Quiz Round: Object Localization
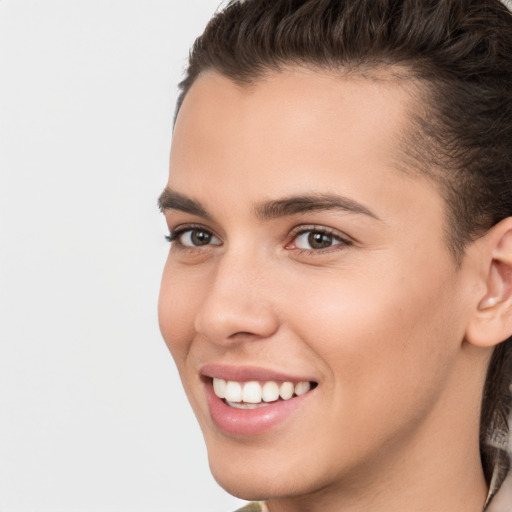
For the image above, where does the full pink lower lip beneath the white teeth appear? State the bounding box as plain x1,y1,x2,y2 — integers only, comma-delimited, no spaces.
206,383,311,436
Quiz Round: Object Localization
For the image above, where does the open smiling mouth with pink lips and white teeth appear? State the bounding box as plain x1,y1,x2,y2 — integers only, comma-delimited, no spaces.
201,365,316,436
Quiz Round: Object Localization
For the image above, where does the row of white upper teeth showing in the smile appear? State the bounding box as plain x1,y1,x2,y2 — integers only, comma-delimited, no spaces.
213,378,311,404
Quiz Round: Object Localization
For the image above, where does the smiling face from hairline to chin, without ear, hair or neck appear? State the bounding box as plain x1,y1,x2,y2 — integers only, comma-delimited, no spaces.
159,69,476,499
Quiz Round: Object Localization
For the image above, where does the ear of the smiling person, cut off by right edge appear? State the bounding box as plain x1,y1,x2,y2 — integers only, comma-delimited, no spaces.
466,217,512,347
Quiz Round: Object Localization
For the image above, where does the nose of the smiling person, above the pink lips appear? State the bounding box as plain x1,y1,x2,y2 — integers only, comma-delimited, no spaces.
195,251,279,345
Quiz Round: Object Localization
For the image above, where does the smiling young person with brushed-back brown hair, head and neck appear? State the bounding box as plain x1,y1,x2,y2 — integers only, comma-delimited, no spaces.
159,0,512,512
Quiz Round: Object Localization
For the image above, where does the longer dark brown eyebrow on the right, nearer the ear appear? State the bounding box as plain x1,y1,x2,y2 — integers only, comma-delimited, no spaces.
256,194,381,220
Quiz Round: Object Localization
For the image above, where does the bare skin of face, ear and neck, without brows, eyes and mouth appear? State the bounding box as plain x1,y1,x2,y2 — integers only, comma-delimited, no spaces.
159,68,512,512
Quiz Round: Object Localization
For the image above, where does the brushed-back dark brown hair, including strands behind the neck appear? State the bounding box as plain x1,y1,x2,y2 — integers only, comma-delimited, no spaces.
176,0,512,498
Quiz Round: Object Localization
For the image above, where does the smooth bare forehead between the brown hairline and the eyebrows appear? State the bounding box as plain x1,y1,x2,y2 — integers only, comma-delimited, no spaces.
169,68,441,234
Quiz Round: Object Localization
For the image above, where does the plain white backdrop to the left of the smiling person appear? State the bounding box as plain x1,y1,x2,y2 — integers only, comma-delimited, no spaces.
0,0,246,512
